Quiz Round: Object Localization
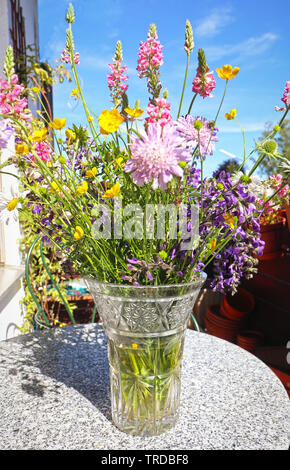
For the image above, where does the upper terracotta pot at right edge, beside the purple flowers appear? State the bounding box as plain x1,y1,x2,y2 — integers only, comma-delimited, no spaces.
257,221,283,260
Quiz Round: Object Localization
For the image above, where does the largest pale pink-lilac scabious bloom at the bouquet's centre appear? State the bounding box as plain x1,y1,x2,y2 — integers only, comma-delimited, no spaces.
124,123,191,190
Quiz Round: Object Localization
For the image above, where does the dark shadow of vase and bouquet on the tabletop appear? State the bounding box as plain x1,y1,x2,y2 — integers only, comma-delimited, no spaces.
4,324,112,421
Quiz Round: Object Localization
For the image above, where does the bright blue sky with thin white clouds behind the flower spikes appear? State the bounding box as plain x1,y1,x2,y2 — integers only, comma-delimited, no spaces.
39,0,290,174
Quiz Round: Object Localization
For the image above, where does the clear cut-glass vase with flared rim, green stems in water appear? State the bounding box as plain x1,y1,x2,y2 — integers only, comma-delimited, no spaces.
85,273,206,436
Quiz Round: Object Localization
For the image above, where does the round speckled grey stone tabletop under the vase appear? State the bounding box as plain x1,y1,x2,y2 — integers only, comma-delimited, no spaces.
0,324,290,451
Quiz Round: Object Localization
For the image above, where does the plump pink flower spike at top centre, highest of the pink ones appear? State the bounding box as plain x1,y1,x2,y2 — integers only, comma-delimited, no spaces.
137,34,163,78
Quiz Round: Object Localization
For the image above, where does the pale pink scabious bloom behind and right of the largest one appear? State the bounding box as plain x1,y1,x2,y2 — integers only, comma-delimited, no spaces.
176,114,218,158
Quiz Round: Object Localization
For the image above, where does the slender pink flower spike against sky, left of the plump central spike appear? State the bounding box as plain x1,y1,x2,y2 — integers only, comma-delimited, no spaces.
107,41,129,107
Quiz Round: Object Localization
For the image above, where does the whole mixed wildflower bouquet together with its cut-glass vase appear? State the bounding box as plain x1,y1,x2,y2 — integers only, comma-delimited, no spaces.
0,5,289,433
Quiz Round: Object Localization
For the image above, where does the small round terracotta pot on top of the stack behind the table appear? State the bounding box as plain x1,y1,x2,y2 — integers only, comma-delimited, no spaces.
220,287,255,321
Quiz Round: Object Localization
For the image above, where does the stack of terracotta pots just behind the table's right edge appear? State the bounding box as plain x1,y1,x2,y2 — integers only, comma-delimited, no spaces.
204,288,255,343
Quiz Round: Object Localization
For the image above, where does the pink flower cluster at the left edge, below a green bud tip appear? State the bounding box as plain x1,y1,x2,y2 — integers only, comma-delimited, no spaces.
0,74,30,119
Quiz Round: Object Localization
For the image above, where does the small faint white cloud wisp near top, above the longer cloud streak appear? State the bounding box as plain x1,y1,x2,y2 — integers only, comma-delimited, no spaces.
194,7,235,37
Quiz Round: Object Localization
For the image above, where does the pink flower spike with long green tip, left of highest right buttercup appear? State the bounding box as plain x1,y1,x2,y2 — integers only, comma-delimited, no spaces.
192,49,216,98
